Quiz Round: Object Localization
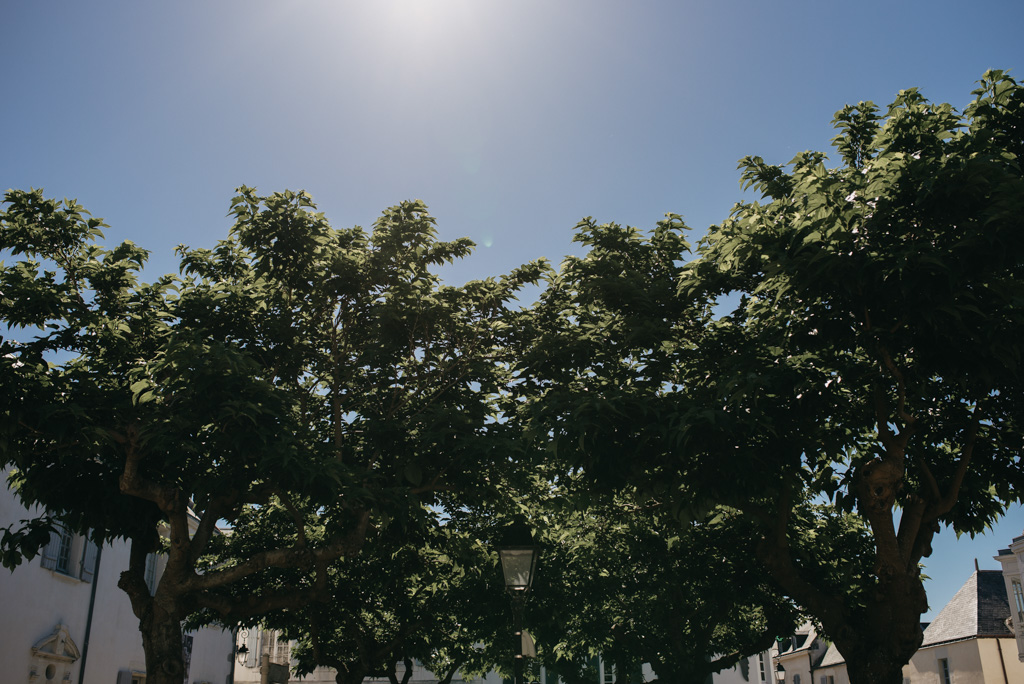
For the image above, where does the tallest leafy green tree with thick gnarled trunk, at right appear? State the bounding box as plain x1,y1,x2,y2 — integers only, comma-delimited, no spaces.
522,72,1024,683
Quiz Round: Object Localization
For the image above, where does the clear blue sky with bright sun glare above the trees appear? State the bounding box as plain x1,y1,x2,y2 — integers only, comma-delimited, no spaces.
0,0,1024,619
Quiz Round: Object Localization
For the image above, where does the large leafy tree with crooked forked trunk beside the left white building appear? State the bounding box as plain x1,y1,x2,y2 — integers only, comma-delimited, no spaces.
0,187,543,684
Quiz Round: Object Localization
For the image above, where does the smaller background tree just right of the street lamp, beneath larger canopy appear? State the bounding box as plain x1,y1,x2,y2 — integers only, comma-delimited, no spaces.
536,483,798,684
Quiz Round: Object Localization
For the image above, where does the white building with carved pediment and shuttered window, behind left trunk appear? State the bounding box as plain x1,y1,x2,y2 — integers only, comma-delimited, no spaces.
0,471,232,684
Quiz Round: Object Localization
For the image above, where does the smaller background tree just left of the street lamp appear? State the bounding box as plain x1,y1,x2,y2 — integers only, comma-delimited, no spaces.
231,506,506,684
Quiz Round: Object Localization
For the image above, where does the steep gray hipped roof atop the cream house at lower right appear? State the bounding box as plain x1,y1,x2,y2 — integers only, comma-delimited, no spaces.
922,570,1013,646
